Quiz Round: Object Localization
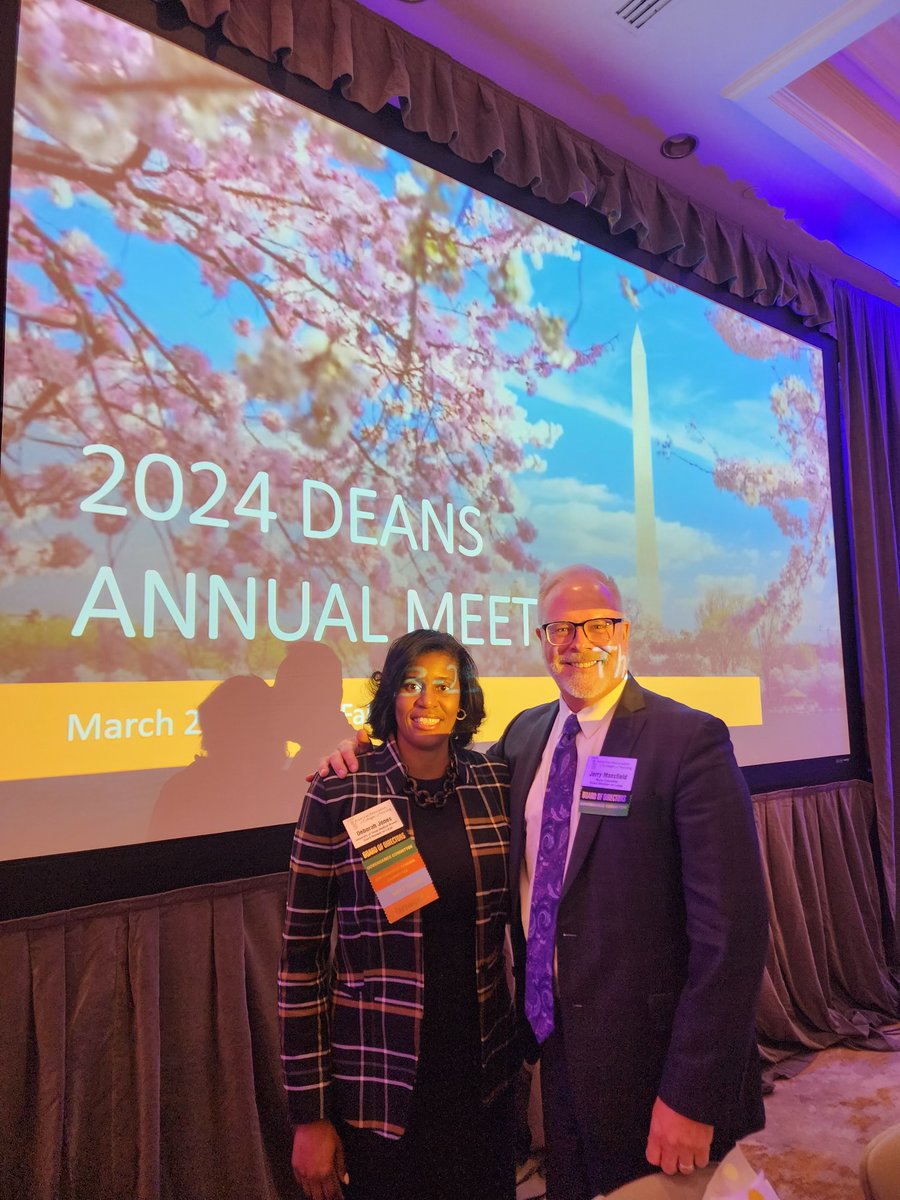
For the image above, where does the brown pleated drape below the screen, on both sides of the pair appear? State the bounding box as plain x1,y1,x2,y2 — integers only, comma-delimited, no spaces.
0,784,898,1200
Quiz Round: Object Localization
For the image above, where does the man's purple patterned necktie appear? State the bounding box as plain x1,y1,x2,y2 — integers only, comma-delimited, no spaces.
526,713,580,1042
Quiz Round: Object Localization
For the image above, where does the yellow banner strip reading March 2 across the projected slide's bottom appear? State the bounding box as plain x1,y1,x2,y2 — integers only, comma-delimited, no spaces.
0,676,762,780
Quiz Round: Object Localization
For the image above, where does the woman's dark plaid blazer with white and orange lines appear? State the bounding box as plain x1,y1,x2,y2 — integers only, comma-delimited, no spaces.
278,742,515,1138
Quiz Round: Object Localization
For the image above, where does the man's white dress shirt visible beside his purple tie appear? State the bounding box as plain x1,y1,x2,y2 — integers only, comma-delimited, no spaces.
518,679,625,937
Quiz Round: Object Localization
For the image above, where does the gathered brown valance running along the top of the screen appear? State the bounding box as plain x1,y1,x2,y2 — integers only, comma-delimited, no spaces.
153,0,834,331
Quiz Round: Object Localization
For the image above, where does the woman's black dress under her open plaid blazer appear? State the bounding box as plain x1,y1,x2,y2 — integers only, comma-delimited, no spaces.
341,779,515,1200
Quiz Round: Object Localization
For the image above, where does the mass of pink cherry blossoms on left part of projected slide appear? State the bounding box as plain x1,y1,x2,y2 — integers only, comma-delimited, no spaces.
0,0,602,673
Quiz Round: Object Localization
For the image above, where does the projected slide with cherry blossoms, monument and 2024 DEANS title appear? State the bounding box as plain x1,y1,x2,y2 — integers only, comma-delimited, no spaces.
0,0,850,859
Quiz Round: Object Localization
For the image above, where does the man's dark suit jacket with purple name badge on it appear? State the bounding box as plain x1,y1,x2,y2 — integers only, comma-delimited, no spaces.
492,677,768,1176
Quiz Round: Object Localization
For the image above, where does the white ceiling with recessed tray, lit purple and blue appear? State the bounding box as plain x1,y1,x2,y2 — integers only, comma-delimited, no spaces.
352,0,900,302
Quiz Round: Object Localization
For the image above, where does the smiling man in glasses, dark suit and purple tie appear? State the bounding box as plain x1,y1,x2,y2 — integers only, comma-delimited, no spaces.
316,565,768,1200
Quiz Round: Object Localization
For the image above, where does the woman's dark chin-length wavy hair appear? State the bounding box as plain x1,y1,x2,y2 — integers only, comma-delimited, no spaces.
368,629,485,746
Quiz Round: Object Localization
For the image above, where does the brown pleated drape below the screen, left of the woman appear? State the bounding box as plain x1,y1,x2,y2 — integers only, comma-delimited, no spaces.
0,874,299,1200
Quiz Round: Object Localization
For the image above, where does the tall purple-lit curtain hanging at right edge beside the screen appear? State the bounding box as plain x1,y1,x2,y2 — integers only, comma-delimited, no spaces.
835,283,900,962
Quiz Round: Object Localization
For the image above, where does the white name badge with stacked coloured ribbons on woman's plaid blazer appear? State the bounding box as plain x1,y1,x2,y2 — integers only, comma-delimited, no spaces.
343,800,438,924
